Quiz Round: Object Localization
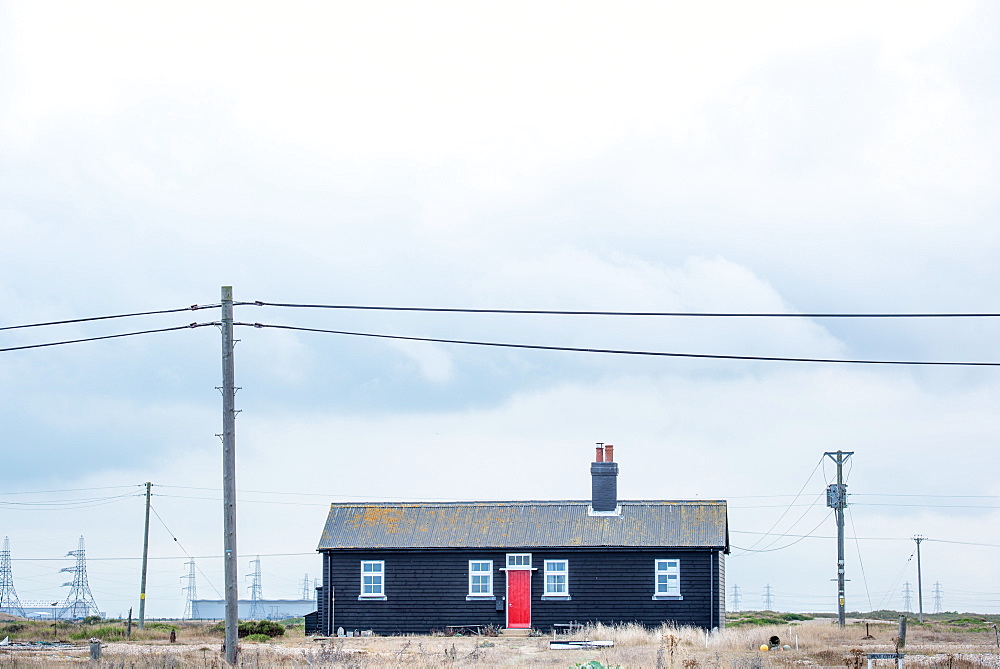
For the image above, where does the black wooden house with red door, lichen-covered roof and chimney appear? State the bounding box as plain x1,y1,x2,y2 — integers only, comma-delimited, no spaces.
307,446,729,634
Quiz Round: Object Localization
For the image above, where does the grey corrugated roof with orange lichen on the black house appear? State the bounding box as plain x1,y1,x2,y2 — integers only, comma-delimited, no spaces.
317,500,729,550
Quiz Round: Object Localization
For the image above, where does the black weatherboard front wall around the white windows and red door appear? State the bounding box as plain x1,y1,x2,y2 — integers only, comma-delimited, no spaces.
319,548,725,634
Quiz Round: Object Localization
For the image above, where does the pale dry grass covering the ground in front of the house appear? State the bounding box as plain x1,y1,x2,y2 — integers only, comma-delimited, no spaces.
0,619,1000,669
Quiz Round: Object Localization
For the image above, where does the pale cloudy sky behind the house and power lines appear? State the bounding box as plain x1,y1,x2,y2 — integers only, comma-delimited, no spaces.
0,1,1000,617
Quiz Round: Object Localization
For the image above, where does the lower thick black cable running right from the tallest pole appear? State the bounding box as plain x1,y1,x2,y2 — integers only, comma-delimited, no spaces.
238,323,1000,367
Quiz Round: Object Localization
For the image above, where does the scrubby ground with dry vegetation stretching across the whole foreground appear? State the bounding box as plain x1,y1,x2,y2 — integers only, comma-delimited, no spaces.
0,611,1000,669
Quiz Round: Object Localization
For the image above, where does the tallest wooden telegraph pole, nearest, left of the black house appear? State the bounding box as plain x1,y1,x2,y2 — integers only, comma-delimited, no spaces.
222,286,239,665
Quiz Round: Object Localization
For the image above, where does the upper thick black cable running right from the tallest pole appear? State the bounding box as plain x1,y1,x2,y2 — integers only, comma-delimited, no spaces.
244,300,1000,318
